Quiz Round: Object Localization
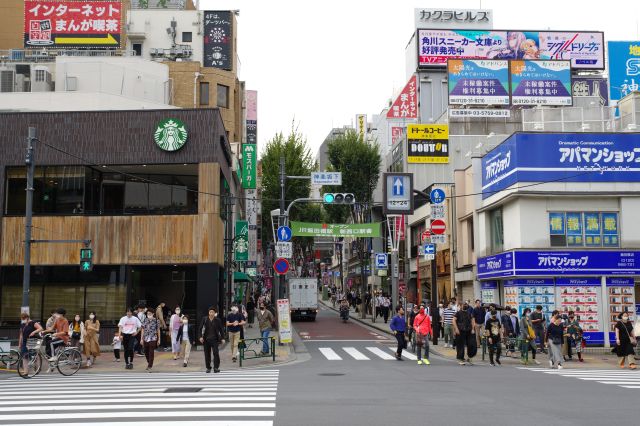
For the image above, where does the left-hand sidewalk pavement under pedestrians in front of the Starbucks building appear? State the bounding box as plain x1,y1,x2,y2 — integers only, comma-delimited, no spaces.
0,322,296,374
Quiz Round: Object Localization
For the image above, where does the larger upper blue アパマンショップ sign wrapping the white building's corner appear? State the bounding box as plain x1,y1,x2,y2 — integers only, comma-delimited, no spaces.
482,133,640,198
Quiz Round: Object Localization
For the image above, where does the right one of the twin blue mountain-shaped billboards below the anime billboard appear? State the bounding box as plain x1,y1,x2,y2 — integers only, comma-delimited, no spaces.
510,61,573,106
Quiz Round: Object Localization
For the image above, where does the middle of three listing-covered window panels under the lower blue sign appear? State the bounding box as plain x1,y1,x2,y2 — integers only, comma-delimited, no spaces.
556,278,601,333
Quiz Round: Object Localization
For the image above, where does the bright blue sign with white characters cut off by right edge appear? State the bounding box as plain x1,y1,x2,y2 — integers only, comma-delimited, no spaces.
607,41,640,105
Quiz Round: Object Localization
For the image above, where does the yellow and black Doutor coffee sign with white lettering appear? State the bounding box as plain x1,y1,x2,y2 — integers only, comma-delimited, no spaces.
407,124,449,164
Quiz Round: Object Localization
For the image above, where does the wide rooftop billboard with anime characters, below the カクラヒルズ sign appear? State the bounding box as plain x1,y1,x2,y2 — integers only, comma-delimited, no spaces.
417,29,604,70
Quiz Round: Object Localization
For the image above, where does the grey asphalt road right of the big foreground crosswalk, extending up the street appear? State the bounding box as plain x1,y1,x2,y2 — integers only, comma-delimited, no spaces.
275,304,640,426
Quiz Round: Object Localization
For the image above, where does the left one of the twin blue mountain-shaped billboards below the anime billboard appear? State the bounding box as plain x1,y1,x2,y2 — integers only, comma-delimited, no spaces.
447,59,509,105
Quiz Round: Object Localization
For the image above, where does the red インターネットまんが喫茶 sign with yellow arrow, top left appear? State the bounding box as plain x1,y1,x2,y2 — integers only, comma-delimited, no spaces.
24,0,123,49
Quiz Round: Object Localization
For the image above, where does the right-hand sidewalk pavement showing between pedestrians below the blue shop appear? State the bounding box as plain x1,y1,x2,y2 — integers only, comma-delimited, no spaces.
320,299,619,369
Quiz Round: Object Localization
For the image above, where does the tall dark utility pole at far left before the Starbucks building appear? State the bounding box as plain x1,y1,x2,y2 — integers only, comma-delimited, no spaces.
20,127,36,314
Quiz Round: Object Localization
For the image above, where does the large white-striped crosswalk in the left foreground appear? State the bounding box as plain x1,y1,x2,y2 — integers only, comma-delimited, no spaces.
0,370,278,426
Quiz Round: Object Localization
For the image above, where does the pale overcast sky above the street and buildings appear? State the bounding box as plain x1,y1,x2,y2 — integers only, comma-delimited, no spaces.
201,0,640,155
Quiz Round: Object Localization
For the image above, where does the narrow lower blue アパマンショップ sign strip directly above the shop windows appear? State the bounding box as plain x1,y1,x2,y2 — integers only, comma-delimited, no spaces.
478,250,640,279
